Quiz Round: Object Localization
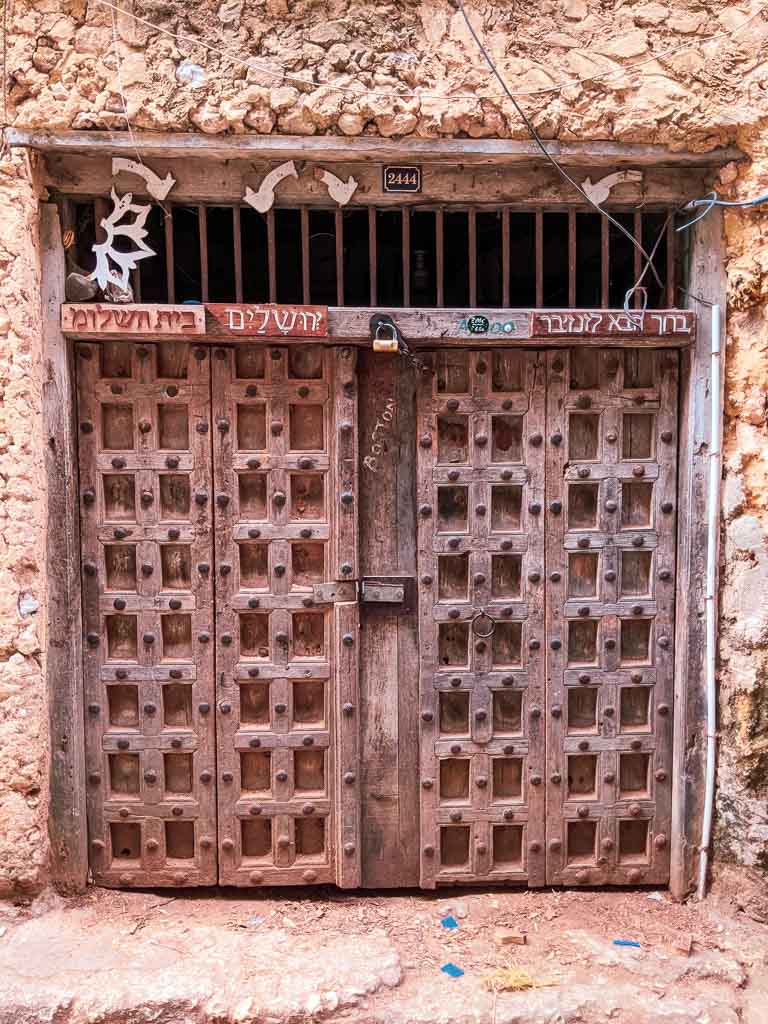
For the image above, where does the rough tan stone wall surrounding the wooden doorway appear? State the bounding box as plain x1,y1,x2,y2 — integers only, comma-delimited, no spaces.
0,0,768,880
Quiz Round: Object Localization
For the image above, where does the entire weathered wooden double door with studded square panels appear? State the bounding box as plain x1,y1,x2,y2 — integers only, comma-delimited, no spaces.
76,342,678,888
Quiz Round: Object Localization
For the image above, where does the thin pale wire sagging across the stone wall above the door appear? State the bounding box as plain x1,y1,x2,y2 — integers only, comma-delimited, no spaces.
95,0,768,103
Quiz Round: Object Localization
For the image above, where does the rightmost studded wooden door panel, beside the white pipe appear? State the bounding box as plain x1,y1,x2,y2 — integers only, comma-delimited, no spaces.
546,349,678,885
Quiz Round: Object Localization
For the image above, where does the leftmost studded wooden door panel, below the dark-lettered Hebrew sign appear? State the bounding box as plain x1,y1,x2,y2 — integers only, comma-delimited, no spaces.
76,342,216,886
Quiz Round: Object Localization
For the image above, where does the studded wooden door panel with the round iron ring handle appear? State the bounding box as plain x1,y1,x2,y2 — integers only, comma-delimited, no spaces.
418,349,545,888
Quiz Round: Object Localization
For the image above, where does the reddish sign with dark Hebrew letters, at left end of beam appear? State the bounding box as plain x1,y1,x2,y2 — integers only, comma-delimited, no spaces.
61,302,206,335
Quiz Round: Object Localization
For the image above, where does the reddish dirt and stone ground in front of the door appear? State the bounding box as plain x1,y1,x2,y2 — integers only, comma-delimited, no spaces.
0,881,768,1024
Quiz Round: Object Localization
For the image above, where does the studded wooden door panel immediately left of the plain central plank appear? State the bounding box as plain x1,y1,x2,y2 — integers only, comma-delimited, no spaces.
213,345,359,887
